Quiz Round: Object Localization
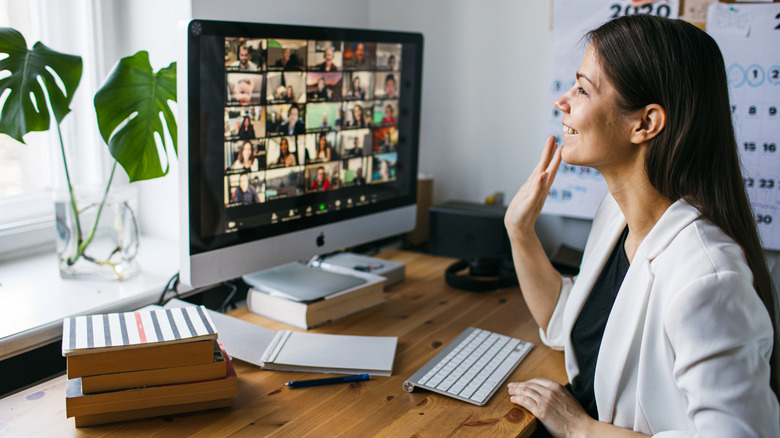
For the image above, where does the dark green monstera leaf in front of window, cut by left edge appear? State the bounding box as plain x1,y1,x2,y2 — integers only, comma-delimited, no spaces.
0,27,82,143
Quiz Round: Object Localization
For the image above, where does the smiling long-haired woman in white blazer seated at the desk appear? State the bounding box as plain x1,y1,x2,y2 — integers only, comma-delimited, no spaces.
505,15,780,437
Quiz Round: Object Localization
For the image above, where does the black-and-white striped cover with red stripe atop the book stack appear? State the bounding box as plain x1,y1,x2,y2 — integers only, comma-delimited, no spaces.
62,306,217,357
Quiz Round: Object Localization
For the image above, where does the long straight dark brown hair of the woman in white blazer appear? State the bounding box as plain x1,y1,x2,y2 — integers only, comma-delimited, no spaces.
586,15,780,395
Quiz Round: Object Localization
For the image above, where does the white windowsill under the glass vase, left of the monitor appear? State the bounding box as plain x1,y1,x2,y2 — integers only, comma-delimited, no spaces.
0,236,179,360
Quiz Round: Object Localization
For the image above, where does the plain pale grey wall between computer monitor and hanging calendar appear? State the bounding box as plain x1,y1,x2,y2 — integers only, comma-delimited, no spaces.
371,0,590,252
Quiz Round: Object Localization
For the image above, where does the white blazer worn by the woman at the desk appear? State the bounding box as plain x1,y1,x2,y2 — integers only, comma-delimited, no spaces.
540,195,780,437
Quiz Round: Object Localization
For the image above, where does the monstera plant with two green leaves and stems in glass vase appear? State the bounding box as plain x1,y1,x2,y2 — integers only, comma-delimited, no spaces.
0,28,177,277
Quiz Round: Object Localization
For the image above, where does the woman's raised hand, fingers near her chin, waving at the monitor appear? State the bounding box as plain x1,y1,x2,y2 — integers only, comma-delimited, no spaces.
504,136,561,237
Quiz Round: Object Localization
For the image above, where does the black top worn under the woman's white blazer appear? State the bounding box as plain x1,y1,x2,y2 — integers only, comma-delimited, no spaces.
571,227,629,419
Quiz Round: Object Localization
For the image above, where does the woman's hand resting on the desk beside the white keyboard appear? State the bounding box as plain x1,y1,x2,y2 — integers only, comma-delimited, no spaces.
507,378,595,437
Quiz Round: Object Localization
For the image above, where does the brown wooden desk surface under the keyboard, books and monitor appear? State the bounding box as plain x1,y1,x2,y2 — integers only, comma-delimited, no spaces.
0,250,566,437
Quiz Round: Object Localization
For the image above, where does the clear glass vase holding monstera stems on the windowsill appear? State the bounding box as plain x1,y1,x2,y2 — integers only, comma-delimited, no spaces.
54,185,140,280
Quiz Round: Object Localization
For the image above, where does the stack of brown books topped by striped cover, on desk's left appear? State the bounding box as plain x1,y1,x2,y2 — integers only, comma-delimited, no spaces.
62,306,238,427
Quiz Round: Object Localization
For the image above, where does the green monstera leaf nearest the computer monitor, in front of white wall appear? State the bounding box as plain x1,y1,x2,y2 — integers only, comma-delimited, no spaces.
95,51,178,182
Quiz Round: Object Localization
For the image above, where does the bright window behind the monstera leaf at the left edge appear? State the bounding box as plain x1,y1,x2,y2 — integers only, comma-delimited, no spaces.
0,0,106,260
